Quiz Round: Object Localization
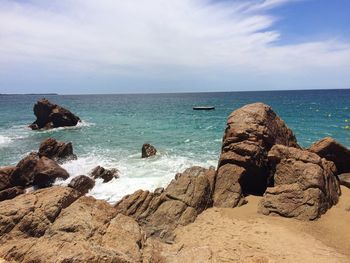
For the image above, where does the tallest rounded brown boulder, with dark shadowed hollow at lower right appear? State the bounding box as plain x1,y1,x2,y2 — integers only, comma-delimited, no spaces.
213,103,299,207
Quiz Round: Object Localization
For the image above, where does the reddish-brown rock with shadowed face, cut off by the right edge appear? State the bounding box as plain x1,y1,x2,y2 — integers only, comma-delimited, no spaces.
309,137,350,174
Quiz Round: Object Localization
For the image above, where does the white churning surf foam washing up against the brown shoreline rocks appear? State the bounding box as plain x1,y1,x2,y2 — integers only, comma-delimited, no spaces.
56,153,217,203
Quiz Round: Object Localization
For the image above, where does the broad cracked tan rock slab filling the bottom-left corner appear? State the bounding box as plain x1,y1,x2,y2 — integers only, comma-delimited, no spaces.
0,187,144,263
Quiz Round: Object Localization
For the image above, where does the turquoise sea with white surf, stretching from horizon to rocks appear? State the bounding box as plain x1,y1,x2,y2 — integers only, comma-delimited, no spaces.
0,90,350,203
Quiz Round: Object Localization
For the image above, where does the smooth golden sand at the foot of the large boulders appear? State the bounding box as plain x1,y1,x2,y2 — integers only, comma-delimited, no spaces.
154,187,350,263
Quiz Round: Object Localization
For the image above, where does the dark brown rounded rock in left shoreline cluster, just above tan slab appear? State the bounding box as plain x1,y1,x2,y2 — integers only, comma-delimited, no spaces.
11,153,69,188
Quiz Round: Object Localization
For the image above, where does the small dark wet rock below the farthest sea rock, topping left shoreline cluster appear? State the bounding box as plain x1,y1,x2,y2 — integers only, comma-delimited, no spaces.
39,138,77,162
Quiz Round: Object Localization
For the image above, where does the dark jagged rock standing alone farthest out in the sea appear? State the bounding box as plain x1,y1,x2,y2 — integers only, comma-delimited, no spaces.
29,99,80,130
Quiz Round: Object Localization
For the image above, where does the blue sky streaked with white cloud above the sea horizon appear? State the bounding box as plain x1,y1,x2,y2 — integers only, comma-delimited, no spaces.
0,0,350,94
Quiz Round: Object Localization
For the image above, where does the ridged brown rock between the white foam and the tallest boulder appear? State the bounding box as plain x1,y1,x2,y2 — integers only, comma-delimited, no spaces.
115,167,215,241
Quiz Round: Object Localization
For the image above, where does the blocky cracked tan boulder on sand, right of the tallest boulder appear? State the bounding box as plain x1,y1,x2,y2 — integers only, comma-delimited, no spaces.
259,145,340,220
